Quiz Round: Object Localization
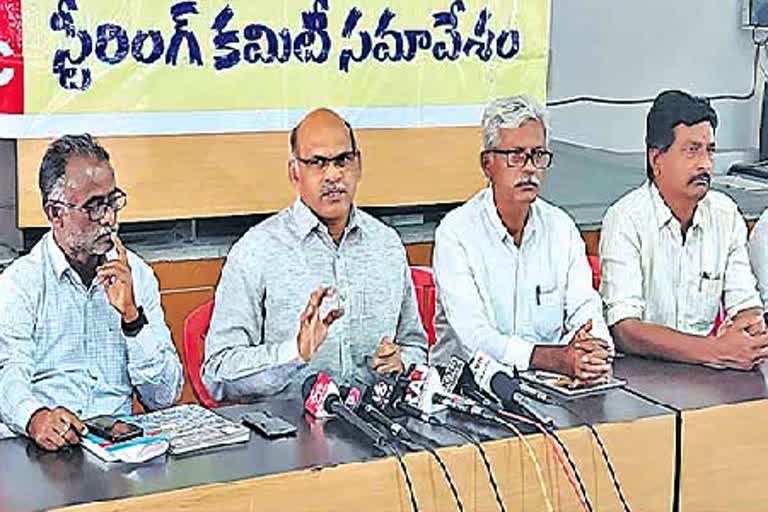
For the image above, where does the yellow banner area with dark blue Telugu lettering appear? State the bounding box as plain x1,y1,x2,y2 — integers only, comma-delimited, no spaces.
22,0,550,115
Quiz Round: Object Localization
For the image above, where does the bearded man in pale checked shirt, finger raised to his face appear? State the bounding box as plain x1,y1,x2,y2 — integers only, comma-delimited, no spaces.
0,135,183,450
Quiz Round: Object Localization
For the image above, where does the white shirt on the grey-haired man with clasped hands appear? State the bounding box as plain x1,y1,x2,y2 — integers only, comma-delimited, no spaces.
430,188,611,370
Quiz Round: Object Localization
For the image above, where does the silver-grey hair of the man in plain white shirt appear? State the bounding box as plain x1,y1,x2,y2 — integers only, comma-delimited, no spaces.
482,94,549,150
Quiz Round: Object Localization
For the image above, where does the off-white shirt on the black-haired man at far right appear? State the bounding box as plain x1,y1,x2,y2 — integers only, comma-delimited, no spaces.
600,182,761,336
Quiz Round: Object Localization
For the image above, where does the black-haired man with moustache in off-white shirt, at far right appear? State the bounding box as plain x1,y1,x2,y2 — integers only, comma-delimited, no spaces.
600,91,768,370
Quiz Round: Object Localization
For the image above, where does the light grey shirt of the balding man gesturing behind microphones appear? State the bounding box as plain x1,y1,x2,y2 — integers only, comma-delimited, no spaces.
202,199,426,400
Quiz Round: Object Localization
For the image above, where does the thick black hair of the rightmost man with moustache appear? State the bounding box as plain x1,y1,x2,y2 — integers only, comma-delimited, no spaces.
645,90,717,181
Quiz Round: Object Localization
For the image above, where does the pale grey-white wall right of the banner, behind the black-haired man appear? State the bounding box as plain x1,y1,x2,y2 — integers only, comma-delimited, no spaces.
548,0,761,151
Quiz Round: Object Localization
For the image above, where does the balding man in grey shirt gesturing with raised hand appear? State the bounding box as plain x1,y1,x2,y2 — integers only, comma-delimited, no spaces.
202,109,426,400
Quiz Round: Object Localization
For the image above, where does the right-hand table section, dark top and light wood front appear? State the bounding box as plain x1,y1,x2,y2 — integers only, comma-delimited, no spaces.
615,356,768,512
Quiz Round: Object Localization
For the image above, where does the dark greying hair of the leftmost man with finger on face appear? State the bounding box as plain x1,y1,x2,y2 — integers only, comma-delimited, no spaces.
38,133,109,206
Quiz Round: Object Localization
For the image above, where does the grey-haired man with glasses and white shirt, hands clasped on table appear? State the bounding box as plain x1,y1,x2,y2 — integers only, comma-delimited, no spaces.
432,96,612,385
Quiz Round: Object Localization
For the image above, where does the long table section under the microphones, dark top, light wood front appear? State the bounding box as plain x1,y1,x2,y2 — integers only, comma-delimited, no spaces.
0,390,674,512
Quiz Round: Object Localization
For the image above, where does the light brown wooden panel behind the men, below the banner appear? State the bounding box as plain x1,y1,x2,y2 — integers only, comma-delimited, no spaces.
17,128,484,227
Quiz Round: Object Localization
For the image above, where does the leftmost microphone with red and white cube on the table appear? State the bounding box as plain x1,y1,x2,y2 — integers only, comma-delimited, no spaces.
301,372,386,447
